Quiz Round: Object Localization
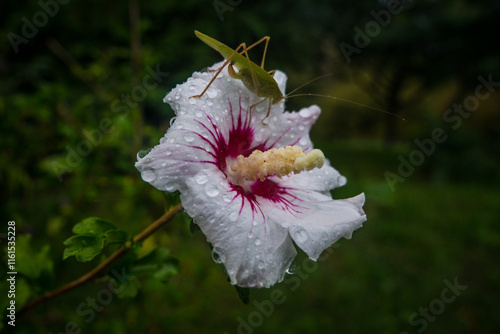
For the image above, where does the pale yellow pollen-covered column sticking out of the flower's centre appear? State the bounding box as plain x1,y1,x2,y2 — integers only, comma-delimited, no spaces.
230,146,325,181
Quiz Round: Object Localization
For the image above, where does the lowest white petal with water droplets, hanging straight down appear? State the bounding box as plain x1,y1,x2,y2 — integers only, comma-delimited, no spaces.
181,171,297,287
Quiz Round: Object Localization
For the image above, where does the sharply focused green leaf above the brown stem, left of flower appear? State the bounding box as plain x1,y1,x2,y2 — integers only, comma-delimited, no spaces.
63,217,127,262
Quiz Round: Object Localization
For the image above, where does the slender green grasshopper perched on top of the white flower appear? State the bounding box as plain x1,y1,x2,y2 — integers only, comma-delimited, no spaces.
191,30,285,119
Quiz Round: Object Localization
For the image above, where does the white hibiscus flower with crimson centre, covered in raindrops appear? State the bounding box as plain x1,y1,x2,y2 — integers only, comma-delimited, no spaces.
136,63,366,287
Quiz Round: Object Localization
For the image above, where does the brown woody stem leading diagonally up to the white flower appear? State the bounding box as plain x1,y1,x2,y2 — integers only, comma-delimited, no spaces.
18,204,182,315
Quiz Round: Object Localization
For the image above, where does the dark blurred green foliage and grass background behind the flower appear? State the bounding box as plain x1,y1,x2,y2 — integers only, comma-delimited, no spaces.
0,0,500,333
